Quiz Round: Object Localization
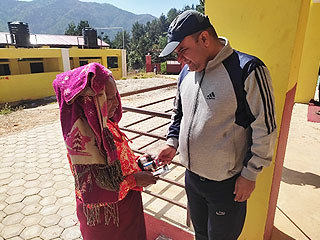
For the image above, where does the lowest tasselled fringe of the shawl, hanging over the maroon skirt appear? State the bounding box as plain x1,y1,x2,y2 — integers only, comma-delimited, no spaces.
83,203,119,227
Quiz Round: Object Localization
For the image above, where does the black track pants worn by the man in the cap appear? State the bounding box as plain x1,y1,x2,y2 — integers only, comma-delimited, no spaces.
185,170,247,240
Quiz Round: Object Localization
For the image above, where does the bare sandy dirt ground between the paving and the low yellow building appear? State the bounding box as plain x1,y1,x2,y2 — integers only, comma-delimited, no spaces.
0,76,176,136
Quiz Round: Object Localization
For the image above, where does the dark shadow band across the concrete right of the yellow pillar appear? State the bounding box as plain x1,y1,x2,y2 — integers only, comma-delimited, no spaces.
282,167,320,188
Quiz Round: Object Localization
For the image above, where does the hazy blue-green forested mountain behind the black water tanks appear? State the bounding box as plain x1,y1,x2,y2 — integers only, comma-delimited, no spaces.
0,0,155,34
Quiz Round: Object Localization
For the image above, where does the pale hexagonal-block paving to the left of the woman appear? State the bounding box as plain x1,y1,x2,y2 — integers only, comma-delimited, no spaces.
0,122,80,240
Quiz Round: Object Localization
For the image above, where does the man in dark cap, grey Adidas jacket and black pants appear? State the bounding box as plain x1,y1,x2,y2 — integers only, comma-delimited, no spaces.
158,10,276,240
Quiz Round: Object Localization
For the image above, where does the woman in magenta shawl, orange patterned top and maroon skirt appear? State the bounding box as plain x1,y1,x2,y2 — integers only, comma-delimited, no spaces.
53,63,157,240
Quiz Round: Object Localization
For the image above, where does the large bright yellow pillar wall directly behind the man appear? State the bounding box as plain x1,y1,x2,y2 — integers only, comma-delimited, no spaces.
205,0,309,240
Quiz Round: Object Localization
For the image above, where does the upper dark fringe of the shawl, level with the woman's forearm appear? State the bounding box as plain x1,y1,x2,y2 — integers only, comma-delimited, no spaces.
72,160,124,192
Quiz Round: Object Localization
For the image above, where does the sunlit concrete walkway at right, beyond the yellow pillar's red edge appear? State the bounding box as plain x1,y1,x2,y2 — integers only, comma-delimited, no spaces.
273,104,320,240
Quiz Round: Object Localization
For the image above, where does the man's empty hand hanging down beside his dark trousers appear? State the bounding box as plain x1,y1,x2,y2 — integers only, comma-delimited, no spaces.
233,176,256,202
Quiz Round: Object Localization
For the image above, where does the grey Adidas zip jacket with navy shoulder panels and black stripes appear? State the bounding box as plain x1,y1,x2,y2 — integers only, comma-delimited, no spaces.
167,38,277,181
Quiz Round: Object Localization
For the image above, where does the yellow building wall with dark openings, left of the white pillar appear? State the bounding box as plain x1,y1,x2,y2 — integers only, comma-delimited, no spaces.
0,48,63,104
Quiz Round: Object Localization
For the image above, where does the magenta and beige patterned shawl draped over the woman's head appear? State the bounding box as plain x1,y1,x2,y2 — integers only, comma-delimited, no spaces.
53,63,123,203
